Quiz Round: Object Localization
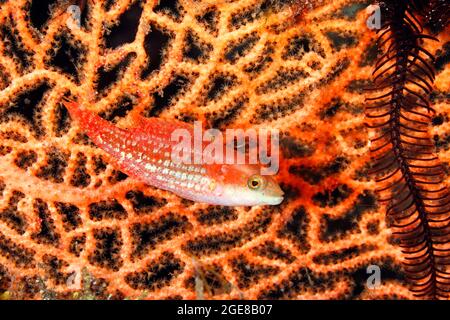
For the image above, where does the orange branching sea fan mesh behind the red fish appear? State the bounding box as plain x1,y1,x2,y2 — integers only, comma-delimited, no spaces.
0,0,450,299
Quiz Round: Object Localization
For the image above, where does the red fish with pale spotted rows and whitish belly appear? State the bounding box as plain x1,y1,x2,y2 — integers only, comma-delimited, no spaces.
63,100,284,206
